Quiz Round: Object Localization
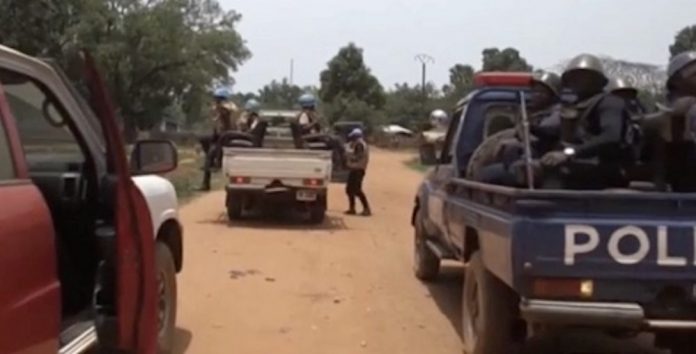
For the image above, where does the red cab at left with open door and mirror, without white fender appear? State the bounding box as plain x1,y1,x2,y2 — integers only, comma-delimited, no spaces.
0,46,177,354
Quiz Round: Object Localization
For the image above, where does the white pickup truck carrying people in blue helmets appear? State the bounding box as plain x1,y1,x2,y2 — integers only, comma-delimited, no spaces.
222,147,332,223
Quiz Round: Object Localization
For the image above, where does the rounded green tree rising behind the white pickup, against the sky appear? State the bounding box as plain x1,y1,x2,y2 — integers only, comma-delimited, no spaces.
319,43,386,113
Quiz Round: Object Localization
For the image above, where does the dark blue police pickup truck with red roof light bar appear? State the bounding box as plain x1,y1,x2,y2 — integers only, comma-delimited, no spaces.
412,73,696,354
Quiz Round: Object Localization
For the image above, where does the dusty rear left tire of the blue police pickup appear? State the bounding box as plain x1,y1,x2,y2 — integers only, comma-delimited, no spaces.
462,251,518,354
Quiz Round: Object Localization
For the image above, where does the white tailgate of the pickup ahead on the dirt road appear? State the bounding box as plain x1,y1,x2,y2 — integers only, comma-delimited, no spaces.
223,148,331,181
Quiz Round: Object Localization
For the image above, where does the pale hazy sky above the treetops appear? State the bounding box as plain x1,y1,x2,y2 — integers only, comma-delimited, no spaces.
219,0,696,92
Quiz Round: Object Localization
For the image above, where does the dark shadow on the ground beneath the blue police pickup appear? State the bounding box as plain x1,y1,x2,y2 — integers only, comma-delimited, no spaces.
418,263,664,354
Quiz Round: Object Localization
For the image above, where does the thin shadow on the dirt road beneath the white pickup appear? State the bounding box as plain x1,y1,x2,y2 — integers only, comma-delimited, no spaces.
198,213,348,231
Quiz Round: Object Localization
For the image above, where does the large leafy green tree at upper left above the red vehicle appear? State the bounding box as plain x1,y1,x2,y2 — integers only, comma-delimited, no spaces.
0,0,250,139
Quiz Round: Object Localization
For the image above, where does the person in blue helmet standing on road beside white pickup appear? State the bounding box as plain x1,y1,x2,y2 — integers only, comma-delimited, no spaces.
346,128,372,216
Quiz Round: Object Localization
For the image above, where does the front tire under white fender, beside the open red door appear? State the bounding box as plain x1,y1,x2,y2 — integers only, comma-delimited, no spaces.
156,242,177,354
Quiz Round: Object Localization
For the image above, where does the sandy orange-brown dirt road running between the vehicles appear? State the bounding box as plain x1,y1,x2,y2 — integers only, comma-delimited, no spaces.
177,151,664,354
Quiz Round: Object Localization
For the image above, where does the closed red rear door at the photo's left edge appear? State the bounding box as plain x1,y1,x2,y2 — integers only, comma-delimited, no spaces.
0,81,61,354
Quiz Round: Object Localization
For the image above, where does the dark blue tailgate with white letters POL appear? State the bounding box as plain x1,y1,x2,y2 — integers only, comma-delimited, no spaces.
512,192,696,280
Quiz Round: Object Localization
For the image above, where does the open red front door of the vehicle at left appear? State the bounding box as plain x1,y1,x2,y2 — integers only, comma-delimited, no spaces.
84,53,158,354
